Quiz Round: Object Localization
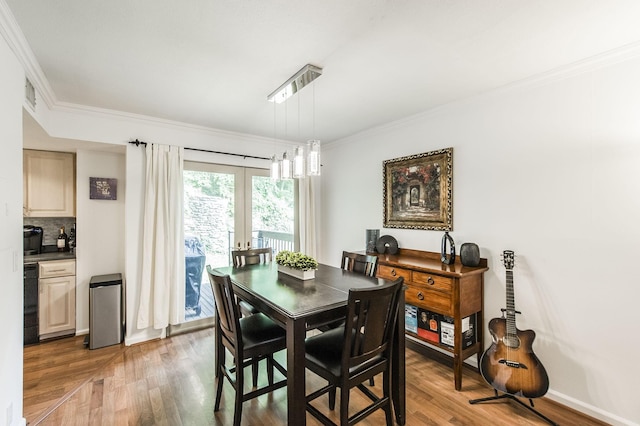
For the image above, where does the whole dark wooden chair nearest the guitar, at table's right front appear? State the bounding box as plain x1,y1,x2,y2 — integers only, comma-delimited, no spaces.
305,277,403,426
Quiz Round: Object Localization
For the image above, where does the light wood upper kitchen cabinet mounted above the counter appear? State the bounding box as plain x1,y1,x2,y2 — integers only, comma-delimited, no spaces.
23,149,76,217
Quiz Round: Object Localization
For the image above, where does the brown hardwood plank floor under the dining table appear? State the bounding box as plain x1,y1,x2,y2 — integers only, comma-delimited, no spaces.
24,328,604,426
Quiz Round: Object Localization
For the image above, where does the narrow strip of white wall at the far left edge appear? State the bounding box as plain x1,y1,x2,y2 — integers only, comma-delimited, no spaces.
0,32,24,425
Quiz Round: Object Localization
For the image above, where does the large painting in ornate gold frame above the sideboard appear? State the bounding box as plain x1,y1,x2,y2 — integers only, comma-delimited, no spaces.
382,148,453,231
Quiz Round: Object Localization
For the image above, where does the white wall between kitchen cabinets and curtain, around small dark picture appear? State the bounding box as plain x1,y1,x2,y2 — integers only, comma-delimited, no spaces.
76,150,126,334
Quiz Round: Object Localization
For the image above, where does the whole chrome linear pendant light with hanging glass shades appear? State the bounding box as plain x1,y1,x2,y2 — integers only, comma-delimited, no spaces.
267,64,322,179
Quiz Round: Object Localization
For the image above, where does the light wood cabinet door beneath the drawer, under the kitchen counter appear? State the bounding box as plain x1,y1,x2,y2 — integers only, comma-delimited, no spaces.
38,276,76,339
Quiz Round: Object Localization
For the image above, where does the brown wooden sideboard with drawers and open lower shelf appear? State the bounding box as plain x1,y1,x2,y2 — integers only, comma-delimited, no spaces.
376,249,489,390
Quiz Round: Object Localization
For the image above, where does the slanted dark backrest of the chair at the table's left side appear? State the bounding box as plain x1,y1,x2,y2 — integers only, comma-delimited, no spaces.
207,265,242,351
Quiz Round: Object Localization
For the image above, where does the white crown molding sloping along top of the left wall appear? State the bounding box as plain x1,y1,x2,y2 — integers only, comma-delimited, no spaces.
0,0,57,108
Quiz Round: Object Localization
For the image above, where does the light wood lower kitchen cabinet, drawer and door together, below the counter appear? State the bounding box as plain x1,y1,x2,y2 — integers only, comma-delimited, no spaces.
38,259,76,340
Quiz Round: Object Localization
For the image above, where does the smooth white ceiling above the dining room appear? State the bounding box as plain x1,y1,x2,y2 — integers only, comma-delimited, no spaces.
7,0,640,142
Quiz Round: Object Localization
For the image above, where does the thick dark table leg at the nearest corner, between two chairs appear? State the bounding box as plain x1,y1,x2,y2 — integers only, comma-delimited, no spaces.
287,319,307,426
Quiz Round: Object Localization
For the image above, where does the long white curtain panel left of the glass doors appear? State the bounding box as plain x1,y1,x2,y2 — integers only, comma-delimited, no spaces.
137,144,185,330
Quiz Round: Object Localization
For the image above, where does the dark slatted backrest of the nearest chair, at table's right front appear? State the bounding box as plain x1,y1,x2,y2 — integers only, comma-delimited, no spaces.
342,277,403,370
